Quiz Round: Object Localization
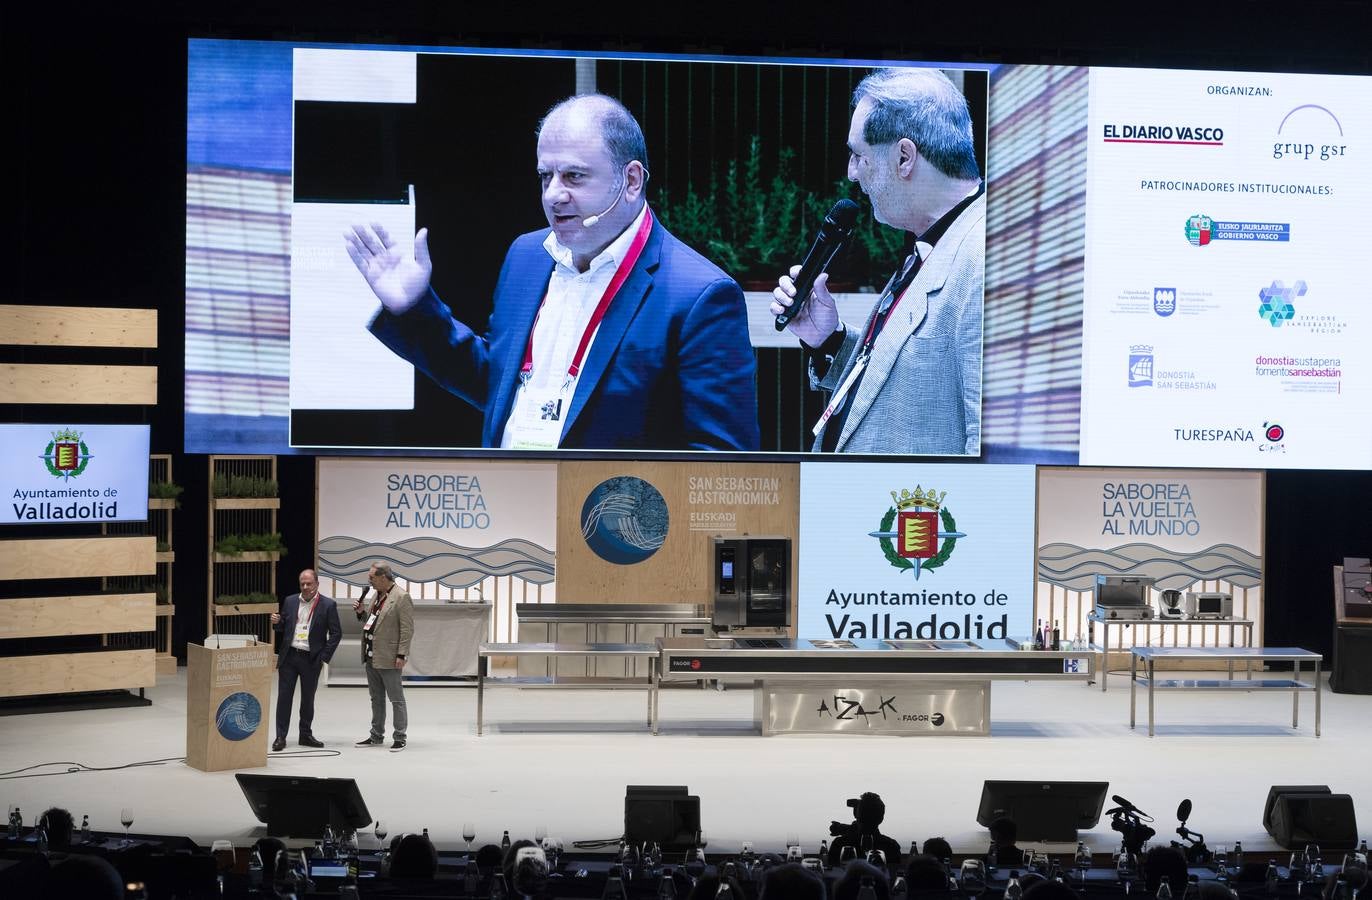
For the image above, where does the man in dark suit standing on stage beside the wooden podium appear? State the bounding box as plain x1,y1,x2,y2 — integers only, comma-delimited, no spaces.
272,569,343,750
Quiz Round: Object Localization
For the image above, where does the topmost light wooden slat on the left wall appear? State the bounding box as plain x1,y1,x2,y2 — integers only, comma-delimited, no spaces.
0,305,158,347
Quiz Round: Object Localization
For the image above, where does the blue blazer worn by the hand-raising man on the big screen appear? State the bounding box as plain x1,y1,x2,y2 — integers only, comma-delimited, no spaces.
370,215,759,450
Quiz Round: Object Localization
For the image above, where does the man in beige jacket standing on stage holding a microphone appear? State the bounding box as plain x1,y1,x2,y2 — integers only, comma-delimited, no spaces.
353,563,414,753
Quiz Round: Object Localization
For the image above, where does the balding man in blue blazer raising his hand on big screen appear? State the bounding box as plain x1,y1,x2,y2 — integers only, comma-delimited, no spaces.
347,95,759,450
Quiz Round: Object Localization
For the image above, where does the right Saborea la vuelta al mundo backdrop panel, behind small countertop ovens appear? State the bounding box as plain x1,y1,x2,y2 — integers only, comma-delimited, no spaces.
1034,468,1264,646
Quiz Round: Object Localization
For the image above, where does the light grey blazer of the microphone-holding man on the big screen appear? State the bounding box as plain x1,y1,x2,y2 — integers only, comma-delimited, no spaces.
812,193,986,455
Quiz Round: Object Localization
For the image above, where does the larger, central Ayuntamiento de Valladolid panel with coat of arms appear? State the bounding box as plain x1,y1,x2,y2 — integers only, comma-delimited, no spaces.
797,462,1034,639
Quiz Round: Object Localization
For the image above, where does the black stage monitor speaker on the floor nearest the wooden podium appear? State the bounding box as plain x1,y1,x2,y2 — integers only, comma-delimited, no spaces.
235,775,372,837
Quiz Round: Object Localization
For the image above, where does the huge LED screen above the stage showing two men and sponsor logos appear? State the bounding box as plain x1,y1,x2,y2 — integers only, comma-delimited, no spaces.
185,41,1372,468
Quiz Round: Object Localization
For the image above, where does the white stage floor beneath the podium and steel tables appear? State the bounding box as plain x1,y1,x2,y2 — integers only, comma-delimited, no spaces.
0,668,1372,853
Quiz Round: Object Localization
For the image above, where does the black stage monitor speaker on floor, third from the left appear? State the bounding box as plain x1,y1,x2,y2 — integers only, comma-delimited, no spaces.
977,781,1110,841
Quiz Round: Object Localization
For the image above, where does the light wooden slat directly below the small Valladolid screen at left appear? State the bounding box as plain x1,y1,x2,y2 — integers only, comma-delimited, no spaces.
0,535,158,580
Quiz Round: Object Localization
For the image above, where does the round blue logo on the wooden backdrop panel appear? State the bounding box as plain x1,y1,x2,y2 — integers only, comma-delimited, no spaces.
582,475,670,565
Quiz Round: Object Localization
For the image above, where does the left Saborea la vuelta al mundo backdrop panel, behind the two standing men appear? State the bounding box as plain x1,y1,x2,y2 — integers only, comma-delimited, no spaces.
316,460,557,641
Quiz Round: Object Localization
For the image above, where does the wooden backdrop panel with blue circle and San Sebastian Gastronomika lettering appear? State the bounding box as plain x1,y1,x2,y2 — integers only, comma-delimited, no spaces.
557,460,800,611
